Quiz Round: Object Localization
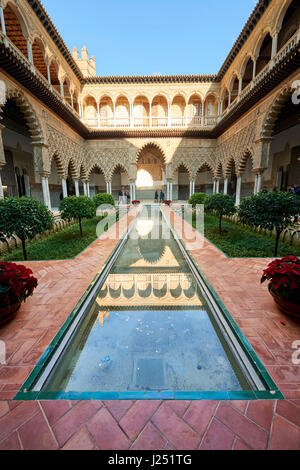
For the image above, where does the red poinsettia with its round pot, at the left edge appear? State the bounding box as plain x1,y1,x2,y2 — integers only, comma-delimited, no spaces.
0,262,38,325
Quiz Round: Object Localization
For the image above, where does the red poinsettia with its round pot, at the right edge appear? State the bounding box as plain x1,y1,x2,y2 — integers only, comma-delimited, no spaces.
261,256,300,318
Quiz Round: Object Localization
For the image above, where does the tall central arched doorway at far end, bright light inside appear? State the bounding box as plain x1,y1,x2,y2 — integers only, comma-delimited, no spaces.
136,144,165,201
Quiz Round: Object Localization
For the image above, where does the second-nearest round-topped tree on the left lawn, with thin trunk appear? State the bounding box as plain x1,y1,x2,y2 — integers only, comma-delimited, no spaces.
59,196,96,237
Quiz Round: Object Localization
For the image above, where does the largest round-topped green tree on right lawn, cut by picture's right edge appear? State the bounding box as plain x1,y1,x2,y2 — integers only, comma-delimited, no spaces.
238,191,300,256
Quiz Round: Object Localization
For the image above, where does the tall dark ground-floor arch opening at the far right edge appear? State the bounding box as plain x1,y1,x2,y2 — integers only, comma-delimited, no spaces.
263,96,300,191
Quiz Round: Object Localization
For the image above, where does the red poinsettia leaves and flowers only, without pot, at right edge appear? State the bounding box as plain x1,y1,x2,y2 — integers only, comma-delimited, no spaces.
261,256,300,302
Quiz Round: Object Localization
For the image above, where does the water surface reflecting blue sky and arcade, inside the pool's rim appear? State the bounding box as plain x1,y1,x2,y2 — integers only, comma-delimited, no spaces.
44,209,250,391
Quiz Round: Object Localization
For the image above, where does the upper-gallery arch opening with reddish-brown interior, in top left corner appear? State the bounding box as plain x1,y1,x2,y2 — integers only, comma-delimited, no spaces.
4,4,28,58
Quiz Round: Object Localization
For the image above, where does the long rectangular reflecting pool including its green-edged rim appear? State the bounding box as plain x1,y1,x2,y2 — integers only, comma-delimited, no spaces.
17,207,281,399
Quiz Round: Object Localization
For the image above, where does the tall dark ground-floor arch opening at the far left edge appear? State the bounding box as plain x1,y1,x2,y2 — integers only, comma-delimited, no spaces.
1,99,43,201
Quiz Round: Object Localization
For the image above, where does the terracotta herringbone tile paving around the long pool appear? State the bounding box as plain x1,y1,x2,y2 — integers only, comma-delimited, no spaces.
0,208,300,450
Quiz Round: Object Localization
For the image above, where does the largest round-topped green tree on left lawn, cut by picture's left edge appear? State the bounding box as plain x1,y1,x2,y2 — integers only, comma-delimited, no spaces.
0,197,54,260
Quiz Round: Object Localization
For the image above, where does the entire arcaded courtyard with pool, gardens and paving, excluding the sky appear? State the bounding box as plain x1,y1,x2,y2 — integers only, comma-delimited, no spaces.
0,0,300,454
